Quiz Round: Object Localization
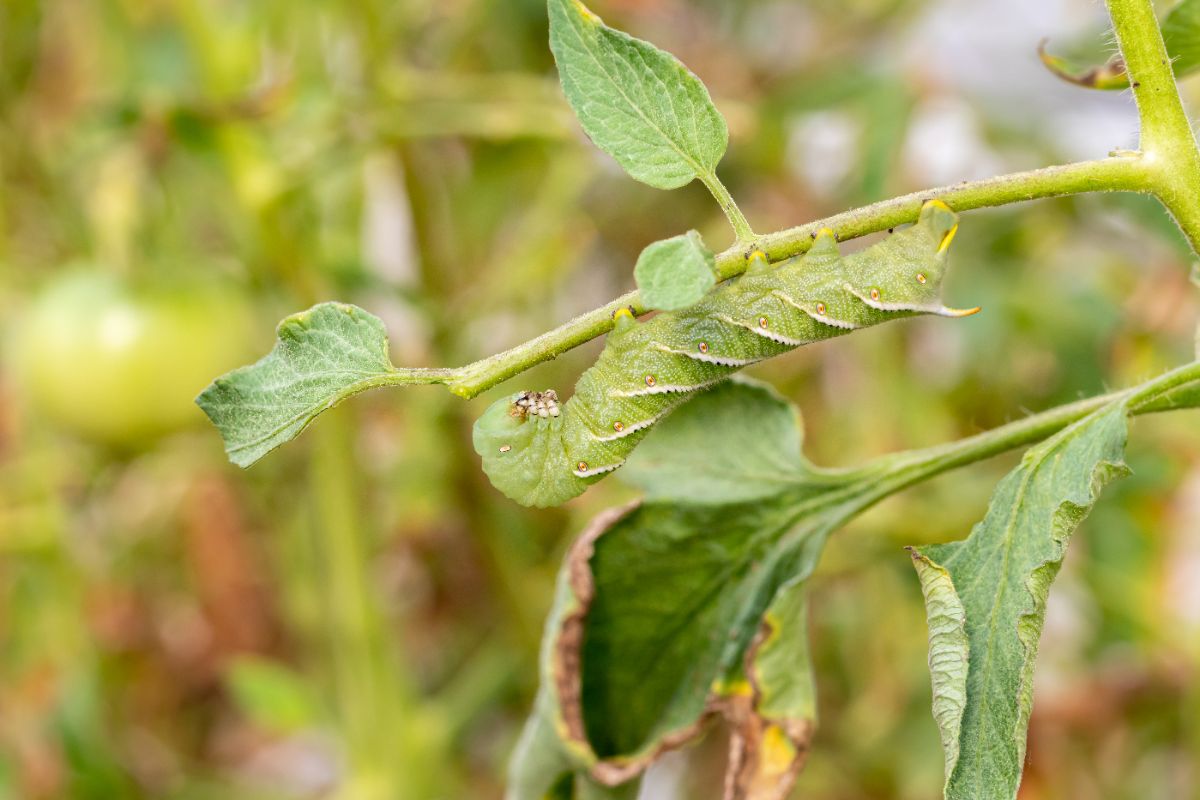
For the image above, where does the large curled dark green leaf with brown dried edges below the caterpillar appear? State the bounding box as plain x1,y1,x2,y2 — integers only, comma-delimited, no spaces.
510,383,887,800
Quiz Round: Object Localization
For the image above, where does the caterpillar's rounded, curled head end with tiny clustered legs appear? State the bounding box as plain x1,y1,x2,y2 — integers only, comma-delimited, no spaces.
472,389,592,507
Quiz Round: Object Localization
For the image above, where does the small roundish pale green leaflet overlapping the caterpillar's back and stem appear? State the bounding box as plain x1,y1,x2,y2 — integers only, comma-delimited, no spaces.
634,230,716,311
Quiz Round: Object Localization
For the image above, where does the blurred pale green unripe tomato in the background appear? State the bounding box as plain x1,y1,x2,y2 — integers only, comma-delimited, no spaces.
16,272,256,447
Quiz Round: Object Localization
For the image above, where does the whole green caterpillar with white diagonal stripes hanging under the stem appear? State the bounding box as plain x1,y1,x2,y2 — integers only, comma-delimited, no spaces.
474,200,979,507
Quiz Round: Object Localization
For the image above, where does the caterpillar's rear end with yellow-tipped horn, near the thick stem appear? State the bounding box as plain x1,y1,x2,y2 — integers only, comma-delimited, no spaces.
846,200,979,317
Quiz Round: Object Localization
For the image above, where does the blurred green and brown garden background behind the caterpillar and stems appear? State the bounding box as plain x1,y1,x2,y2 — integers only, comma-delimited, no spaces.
0,0,1200,800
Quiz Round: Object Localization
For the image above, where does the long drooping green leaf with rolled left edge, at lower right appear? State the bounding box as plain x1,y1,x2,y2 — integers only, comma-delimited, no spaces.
913,403,1128,799
